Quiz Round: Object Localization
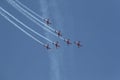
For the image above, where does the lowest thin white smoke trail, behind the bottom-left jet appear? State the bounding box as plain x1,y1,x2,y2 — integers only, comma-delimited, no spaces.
0,7,44,46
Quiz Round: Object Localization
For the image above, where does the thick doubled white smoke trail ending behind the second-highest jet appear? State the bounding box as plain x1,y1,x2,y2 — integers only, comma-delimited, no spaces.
7,0,64,40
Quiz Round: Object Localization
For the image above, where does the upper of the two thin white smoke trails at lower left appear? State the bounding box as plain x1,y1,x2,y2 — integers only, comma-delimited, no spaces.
0,8,53,43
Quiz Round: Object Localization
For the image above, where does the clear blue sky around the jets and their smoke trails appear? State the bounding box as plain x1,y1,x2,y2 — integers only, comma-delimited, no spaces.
0,0,120,80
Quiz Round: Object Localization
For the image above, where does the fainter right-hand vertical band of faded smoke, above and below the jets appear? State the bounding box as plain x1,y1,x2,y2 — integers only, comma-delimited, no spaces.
48,0,65,80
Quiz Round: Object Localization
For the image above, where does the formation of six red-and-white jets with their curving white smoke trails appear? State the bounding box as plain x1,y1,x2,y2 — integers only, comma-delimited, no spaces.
0,0,82,50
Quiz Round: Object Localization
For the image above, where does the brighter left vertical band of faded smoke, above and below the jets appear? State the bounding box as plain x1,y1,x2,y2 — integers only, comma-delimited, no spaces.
40,0,61,80
